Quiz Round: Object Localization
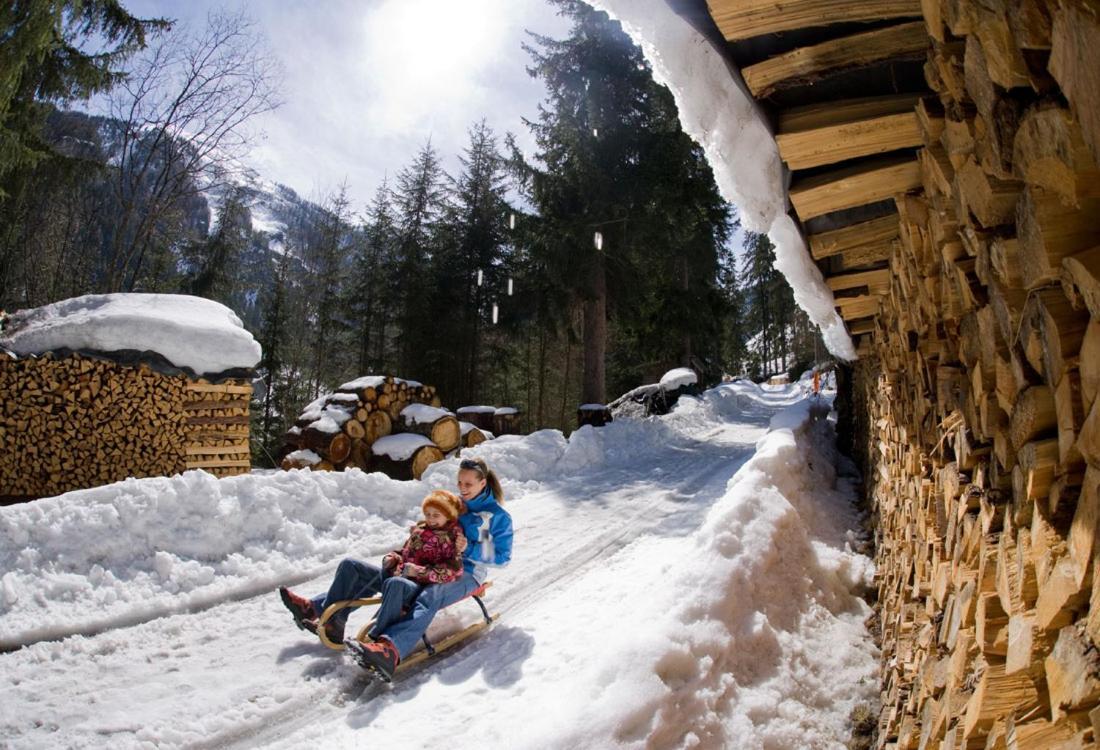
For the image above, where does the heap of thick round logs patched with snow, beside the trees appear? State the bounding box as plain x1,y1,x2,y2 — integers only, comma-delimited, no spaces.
282,375,495,478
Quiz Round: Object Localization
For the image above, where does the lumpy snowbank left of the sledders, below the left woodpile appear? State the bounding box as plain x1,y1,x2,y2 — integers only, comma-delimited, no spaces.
0,470,424,648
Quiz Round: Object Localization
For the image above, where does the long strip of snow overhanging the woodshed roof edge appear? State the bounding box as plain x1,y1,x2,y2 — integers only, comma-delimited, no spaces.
585,0,858,362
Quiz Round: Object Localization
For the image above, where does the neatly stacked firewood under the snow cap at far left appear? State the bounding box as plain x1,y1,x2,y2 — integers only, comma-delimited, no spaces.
0,353,251,500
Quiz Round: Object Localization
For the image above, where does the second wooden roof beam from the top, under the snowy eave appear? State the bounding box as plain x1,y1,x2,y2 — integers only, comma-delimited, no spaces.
741,21,930,99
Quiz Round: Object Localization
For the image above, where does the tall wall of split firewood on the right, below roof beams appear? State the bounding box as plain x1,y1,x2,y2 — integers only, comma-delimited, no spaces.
856,0,1100,750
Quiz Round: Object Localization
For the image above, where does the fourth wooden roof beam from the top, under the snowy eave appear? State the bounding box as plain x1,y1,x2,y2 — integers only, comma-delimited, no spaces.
791,156,922,221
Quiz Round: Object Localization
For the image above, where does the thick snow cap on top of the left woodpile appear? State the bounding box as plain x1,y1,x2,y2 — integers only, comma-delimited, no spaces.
0,294,261,375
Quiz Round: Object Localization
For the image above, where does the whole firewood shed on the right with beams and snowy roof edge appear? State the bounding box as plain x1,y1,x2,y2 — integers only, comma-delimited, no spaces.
594,0,1100,749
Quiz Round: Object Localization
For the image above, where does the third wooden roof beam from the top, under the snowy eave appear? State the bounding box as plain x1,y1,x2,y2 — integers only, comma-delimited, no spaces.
776,95,924,169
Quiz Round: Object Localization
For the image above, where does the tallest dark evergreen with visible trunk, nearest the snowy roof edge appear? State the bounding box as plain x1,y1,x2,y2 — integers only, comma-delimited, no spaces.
528,0,729,401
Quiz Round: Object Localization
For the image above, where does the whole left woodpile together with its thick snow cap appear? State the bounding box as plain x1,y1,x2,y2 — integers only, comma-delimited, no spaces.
0,295,260,499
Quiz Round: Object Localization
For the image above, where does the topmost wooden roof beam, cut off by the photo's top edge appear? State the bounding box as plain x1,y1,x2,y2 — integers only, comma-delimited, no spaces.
706,0,921,42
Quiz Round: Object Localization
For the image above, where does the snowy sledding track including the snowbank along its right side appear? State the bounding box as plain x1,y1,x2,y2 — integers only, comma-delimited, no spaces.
0,382,875,748
